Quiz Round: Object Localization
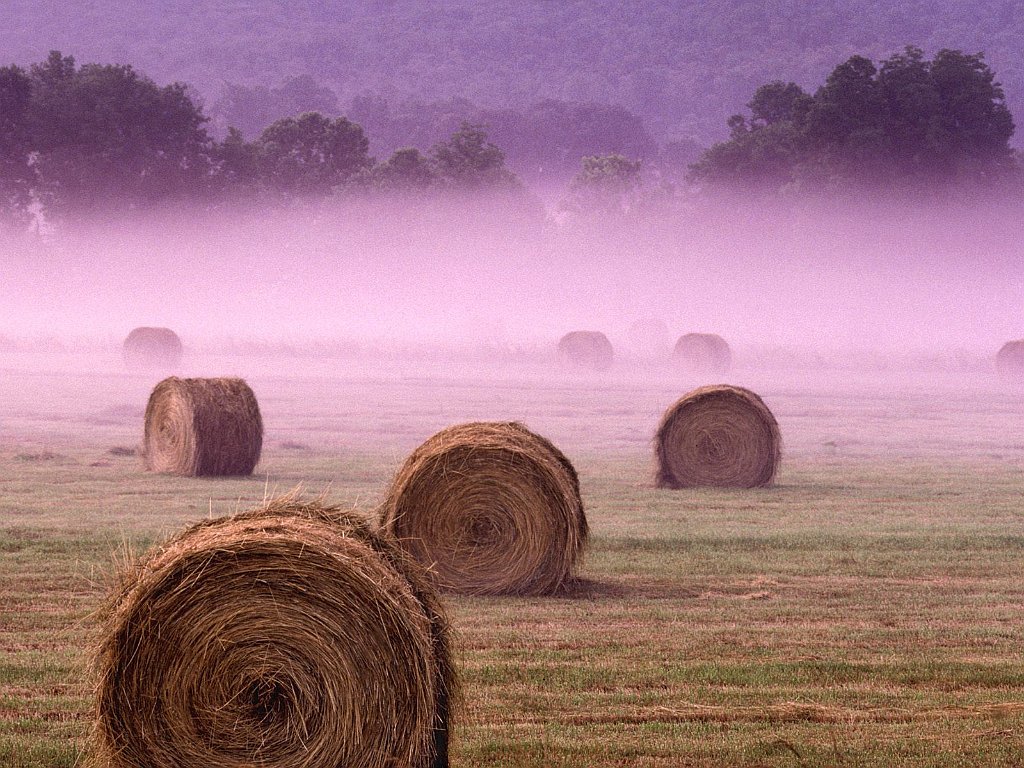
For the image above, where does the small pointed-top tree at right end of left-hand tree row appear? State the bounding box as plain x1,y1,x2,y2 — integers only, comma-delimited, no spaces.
430,123,519,189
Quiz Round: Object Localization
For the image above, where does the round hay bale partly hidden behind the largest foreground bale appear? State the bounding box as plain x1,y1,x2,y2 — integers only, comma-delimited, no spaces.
381,422,588,595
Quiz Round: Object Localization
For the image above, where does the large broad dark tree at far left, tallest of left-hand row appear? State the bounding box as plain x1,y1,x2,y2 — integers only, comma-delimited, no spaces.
29,51,213,217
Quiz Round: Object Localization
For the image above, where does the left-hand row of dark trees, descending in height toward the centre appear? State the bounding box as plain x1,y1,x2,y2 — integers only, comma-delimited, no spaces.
0,51,520,226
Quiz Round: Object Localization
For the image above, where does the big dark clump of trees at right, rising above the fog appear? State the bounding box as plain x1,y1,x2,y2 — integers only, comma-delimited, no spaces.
691,46,1015,189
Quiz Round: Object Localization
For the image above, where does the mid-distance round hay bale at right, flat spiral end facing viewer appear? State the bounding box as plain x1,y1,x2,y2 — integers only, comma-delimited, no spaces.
655,384,782,488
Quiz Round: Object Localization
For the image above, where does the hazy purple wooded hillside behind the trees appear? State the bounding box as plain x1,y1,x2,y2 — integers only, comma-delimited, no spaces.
0,0,1024,143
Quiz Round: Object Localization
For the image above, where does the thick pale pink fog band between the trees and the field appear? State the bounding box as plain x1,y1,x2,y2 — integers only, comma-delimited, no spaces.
0,193,1024,366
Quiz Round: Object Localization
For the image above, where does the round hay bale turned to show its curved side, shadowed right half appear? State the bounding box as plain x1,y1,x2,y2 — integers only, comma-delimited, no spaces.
142,376,263,477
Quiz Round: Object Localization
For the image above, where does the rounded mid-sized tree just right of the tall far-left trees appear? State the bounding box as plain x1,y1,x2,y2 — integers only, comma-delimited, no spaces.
256,112,373,197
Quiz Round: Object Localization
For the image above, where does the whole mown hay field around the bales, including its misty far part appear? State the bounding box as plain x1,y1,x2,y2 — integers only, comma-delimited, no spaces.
0,352,1024,768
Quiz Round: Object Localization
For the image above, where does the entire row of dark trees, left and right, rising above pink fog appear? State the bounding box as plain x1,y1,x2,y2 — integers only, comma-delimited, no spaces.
0,47,1020,234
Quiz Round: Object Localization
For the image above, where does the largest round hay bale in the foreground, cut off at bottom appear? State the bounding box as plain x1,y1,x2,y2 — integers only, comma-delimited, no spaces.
91,497,458,768
